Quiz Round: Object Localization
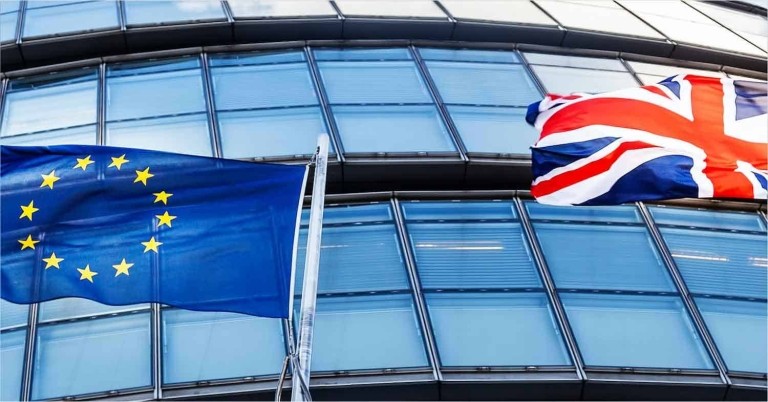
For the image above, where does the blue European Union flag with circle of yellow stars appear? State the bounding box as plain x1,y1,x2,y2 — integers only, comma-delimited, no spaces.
0,145,306,317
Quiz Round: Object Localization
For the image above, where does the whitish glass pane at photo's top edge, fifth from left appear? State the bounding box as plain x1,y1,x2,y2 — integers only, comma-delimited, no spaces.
336,0,447,19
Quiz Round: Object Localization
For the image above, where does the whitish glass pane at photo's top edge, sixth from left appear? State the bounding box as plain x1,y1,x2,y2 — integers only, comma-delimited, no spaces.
440,0,556,25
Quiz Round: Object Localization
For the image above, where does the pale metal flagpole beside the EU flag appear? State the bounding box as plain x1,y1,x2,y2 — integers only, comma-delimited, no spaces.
291,134,329,401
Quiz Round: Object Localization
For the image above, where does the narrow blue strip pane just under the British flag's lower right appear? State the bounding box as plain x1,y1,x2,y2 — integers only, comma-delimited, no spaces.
649,207,765,231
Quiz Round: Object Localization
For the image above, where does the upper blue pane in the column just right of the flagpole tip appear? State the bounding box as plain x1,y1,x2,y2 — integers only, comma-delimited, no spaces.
318,61,432,104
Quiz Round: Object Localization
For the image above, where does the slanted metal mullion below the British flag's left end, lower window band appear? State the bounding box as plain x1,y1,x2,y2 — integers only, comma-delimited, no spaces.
514,197,587,381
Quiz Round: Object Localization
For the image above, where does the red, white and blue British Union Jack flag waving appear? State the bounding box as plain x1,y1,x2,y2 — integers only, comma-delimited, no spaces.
526,74,768,205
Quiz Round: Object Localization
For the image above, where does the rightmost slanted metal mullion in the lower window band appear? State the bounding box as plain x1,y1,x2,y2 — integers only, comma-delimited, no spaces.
637,202,732,386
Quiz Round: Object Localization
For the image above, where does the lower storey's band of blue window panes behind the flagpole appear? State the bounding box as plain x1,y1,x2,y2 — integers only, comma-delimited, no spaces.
0,200,768,400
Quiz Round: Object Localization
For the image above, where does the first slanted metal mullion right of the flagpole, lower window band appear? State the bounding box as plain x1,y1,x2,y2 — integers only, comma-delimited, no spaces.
391,197,443,381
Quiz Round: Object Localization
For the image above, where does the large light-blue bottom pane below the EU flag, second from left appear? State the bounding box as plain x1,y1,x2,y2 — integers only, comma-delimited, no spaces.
32,313,152,399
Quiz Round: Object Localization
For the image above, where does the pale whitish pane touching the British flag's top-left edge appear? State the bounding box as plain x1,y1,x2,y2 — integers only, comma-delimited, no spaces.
531,65,638,94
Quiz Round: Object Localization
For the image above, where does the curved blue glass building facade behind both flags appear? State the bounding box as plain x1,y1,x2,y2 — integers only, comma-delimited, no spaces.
0,0,768,400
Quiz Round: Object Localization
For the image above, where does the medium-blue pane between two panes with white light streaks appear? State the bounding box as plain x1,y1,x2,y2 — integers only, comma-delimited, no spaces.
534,223,675,292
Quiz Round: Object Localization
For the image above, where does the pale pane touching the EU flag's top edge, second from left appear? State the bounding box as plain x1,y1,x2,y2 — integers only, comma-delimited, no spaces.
106,114,213,156
